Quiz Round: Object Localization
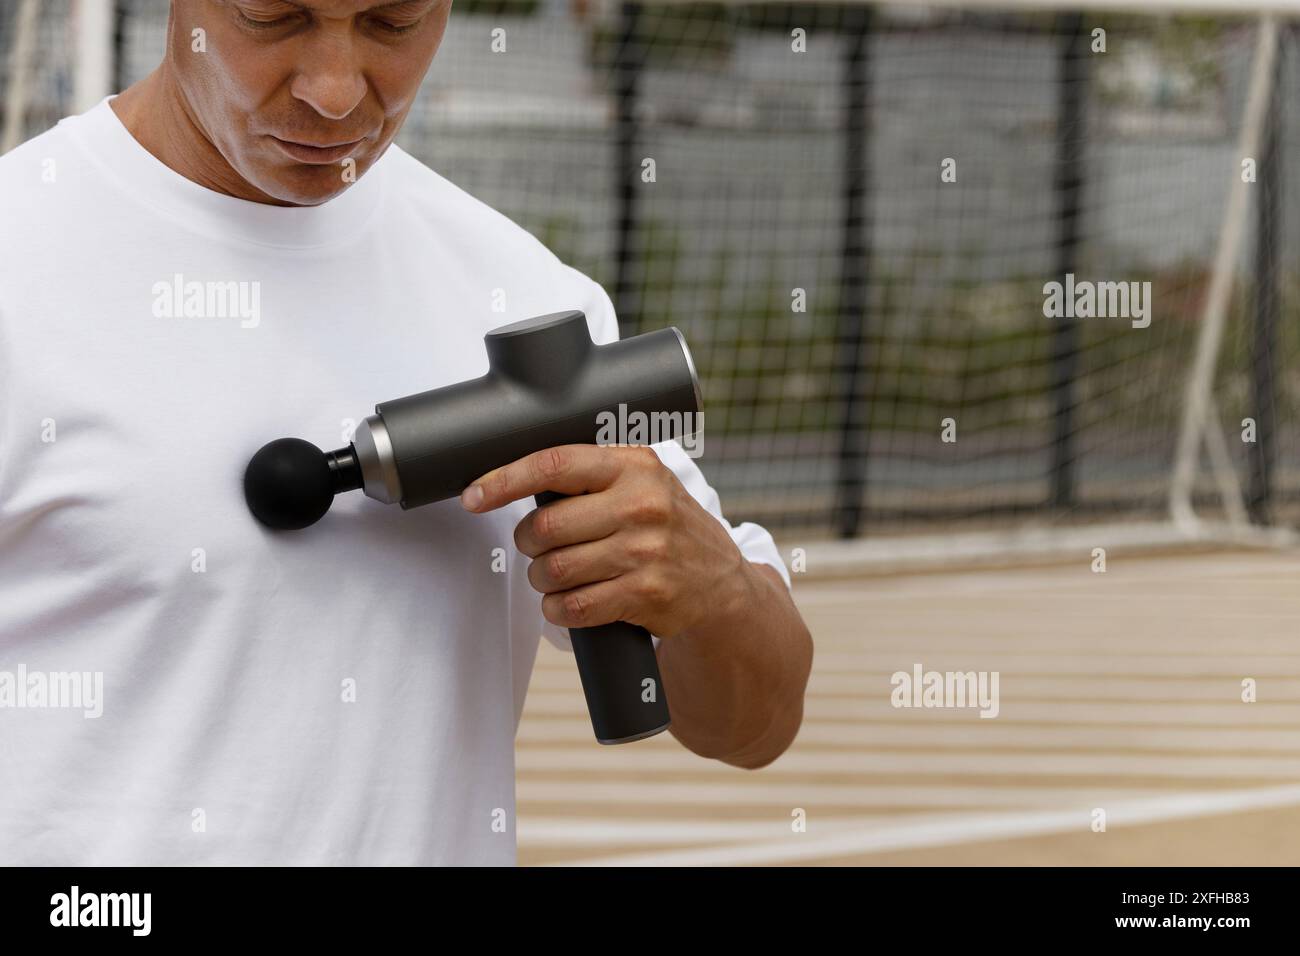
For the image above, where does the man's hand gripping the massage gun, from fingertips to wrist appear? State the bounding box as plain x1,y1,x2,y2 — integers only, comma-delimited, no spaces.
462,445,748,639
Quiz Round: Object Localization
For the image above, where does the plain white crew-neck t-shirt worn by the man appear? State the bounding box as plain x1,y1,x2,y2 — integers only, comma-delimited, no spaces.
0,100,789,865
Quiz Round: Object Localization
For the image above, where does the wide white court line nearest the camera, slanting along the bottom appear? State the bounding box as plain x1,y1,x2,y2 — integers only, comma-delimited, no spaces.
551,786,1300,866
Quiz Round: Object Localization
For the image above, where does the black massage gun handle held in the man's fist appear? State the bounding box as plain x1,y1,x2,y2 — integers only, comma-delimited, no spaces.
534,492,670,744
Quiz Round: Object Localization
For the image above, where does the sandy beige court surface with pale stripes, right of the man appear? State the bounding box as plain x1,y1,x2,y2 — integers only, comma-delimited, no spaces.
516,551,1300,865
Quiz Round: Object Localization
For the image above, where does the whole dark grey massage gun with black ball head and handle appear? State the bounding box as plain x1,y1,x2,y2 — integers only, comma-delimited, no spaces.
244,311,701,744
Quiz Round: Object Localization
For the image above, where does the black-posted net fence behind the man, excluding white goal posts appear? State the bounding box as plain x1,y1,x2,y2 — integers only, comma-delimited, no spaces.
0,0,1300,536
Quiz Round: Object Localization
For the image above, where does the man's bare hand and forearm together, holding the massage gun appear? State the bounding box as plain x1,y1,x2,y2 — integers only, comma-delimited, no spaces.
462,445,813,769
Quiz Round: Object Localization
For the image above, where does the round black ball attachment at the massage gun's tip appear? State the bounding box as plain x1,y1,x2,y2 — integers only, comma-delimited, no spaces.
244,438,334,531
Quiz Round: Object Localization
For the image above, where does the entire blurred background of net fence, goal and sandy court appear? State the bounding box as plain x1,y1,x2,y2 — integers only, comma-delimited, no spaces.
0,0,1300,864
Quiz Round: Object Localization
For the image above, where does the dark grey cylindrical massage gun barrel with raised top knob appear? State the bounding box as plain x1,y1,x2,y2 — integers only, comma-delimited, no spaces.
376,311,699,509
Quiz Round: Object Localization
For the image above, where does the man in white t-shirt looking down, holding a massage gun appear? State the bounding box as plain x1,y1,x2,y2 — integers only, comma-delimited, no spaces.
0,0,811,865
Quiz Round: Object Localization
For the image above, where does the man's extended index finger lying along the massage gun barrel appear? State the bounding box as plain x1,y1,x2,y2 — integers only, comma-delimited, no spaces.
460,445,619,511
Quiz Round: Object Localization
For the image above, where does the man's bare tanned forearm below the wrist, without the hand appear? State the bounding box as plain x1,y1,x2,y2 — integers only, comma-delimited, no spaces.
659,558,813,769
